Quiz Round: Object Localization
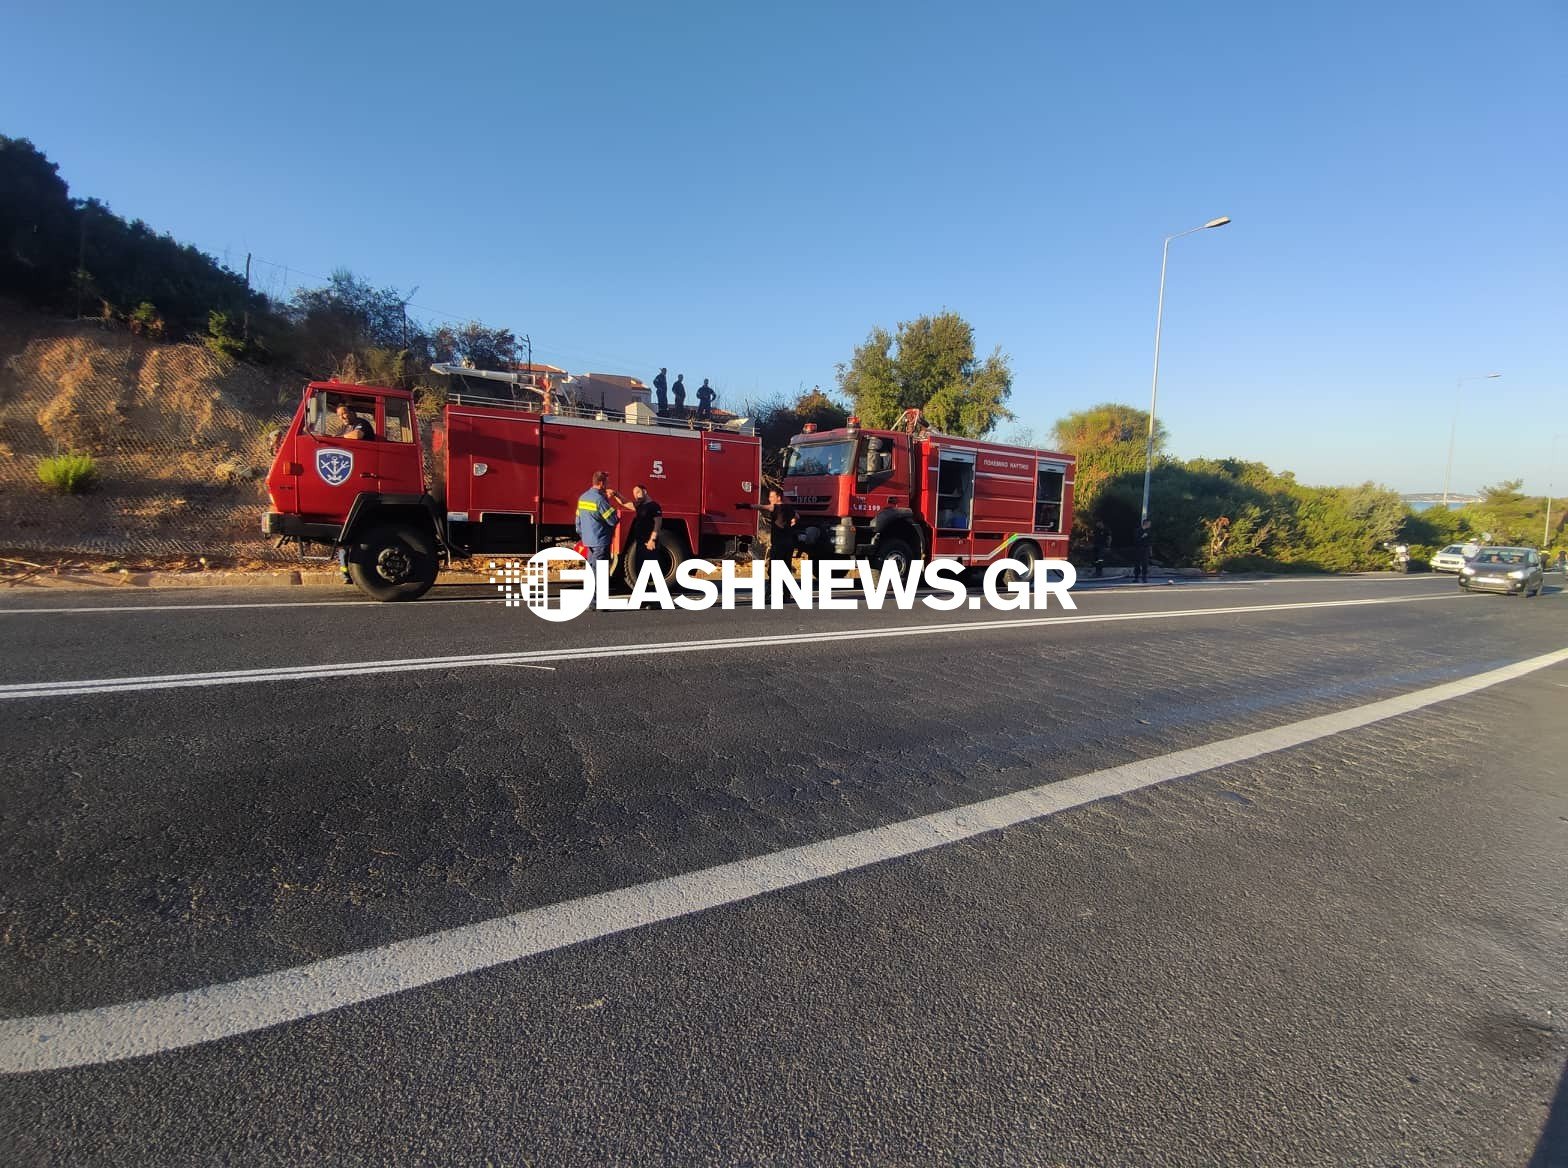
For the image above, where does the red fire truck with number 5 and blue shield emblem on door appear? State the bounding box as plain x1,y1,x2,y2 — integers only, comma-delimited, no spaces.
262,381,762,600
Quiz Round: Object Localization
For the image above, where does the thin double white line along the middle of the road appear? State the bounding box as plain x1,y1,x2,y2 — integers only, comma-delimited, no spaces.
0,593,1458,701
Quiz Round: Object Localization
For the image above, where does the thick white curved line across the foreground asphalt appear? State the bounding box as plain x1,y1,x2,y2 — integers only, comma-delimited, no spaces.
0,649,1568,1074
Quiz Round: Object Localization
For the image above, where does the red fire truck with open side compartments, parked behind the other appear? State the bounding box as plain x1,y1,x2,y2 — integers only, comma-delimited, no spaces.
784,409,1077,571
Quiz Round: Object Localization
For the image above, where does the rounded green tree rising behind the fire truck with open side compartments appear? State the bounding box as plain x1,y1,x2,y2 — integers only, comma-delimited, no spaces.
839,312,1013,437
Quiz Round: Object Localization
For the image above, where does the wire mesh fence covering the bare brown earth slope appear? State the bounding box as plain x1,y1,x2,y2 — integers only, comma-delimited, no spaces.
0,323,299,560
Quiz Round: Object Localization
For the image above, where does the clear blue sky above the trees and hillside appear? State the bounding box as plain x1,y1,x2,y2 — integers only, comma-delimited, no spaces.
0,0,1568,491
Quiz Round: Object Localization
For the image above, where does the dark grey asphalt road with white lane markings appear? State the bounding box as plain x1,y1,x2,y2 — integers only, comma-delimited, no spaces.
0,575,1568,1165
